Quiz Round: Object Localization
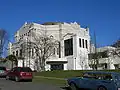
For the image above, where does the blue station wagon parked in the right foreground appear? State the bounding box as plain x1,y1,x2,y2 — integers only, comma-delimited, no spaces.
67,71,120,90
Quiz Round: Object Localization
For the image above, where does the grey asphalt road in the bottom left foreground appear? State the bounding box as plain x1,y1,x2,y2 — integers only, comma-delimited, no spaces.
0,78,65,90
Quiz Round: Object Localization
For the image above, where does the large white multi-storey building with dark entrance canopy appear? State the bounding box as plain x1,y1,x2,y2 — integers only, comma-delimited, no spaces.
9,22,90,70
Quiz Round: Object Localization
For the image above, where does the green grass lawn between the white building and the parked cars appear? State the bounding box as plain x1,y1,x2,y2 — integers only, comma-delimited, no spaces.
33,70,120,86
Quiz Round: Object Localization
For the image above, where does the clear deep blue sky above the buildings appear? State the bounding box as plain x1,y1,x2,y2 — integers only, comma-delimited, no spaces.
0,0,120,46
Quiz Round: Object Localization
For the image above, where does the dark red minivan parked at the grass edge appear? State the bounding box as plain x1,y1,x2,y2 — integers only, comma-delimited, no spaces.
6,67,33,82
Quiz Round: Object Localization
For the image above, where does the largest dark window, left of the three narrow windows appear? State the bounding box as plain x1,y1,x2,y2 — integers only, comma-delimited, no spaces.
64,38,73,56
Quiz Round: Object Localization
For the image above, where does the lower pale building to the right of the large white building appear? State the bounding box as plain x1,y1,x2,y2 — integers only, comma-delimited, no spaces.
89,46,120,70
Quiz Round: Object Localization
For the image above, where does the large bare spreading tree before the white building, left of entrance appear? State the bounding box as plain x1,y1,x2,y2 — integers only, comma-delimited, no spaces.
22,32,58,71
